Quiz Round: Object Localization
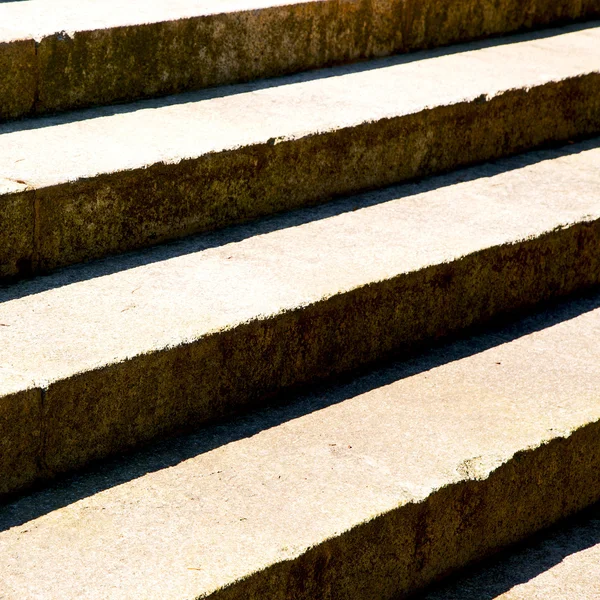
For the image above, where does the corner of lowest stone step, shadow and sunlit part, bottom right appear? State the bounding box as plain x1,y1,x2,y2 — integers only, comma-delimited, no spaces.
415,504,600,600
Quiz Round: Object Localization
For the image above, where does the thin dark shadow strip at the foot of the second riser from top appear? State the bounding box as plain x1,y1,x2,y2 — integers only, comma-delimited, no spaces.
0,138,600,304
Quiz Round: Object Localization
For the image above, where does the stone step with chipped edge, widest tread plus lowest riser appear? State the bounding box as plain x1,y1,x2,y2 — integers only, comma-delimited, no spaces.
0,295,600,600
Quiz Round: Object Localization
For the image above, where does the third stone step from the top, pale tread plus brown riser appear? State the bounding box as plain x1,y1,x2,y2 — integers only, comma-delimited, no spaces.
0,139,600,494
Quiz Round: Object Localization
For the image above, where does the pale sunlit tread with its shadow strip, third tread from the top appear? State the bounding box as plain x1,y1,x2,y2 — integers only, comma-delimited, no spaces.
0,140,600,386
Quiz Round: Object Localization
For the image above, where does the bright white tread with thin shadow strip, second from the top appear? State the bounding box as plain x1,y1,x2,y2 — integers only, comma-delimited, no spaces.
0,27,600,193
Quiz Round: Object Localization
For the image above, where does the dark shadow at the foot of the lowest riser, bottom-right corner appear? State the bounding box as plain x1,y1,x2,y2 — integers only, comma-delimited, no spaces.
412,504,600,600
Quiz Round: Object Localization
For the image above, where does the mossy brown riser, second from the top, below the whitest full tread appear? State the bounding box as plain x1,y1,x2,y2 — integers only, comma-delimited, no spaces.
0,73,600,278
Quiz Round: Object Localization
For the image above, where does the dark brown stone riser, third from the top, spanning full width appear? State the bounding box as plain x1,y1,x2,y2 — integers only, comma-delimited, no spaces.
0,221,600,494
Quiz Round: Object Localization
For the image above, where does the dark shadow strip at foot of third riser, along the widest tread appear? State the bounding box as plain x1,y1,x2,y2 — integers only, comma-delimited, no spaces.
0,290,600,531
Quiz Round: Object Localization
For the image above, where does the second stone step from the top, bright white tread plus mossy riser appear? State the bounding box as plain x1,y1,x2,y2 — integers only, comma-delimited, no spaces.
0,24,600,277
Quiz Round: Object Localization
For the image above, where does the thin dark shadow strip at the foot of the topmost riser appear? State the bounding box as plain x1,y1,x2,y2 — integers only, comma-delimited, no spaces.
0,21,600,135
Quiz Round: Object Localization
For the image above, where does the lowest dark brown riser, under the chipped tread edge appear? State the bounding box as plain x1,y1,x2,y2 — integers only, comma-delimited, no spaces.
207,422,600,600
